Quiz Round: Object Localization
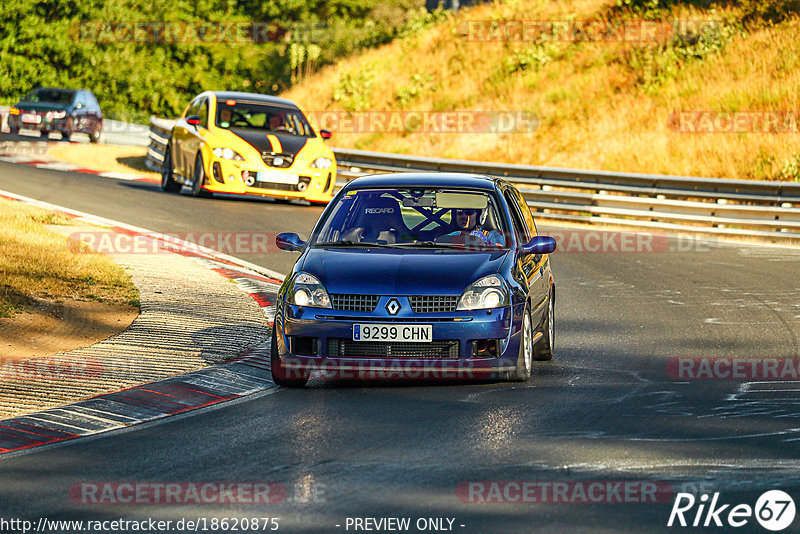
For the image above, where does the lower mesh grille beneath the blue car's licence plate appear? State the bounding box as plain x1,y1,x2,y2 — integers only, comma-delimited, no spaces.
328,339,459,359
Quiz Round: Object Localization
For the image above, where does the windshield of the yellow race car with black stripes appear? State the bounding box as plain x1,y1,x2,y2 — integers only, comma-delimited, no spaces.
215,99,314,137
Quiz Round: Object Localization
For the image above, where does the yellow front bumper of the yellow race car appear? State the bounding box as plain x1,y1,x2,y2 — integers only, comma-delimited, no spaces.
204,157,336,202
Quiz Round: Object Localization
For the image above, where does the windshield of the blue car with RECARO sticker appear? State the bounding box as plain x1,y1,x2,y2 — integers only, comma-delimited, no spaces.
311,188,507,250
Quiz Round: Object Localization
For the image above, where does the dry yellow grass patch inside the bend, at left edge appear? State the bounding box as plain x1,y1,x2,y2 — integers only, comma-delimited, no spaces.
0,199,139,317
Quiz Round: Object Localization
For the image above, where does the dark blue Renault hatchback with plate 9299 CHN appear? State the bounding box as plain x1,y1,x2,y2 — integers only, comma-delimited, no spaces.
271,173,556,386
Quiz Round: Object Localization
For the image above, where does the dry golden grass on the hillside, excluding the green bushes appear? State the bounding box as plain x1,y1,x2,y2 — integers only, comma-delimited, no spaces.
282,0,800,179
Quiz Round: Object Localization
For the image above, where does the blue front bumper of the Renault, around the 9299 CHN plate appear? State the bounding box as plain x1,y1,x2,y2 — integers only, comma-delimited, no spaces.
276,297,520,379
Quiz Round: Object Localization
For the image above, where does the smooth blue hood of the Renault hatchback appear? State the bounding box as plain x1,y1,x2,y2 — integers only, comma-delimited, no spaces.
300,248,509,295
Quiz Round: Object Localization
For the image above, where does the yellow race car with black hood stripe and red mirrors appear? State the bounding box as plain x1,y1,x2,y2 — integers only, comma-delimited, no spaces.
161,91,336,202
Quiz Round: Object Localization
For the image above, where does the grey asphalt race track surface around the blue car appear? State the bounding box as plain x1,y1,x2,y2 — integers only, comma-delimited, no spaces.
0,158,800,533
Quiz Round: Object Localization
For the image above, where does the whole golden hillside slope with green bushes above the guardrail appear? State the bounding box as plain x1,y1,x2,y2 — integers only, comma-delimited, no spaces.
283,0,800,180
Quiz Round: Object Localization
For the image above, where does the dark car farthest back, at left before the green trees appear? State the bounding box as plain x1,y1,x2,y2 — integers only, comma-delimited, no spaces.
8,87,103,143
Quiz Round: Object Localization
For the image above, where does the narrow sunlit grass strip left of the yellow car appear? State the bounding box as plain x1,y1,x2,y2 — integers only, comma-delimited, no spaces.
47,143,158,178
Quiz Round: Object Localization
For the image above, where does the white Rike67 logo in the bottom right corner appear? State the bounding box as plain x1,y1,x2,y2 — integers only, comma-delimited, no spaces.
667,490,796,532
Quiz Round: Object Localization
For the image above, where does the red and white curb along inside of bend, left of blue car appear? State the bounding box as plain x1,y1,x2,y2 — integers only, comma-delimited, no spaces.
0,191,283,454
